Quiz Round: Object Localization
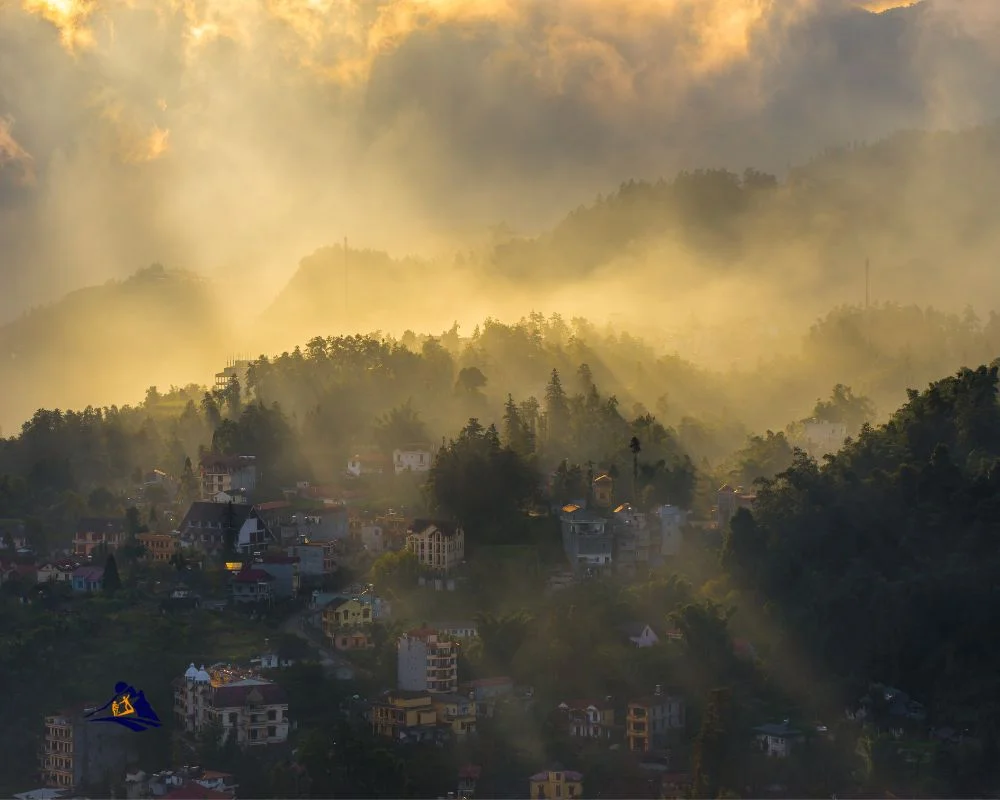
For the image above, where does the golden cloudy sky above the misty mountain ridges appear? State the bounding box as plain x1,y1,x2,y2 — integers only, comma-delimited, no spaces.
0,0,1000,320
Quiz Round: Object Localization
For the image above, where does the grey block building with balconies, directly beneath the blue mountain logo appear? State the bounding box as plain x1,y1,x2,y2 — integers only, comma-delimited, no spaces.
39,704,136,790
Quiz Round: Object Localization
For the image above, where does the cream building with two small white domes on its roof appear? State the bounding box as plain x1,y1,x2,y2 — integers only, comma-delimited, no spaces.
174,664,289,747
